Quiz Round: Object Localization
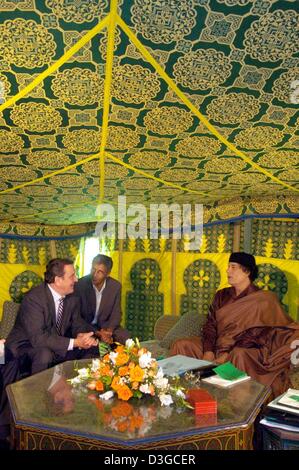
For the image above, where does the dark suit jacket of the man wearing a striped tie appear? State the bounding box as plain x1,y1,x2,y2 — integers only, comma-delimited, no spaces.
5,283,92,356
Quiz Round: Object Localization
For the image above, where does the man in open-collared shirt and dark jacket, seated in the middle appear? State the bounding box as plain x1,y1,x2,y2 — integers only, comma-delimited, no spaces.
75,255,130,344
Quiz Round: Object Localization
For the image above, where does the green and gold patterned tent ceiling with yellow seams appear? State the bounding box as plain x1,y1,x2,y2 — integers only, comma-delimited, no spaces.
0,0,299,225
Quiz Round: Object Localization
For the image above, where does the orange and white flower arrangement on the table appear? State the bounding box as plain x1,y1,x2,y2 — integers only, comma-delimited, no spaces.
71,339,191,407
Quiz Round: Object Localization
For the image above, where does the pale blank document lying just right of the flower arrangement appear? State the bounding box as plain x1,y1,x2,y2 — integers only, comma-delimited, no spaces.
158,354,215,376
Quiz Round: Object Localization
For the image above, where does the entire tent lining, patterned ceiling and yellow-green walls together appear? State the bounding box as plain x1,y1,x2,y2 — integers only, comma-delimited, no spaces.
0,0,299,339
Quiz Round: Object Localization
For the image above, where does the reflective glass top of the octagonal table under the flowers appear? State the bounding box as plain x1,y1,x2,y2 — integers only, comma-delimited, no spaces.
7,360,269,444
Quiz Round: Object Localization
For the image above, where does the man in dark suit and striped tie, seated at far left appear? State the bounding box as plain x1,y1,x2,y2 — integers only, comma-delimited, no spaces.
6,258,98,374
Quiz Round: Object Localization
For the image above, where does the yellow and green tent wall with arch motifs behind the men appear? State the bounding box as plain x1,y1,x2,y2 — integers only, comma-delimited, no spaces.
0,218,299,340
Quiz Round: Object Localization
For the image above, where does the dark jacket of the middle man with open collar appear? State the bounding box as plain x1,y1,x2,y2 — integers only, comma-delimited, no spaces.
75,275,121,330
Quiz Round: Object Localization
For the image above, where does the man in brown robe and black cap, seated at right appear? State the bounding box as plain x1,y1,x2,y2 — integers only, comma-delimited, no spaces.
171,252,299,396
